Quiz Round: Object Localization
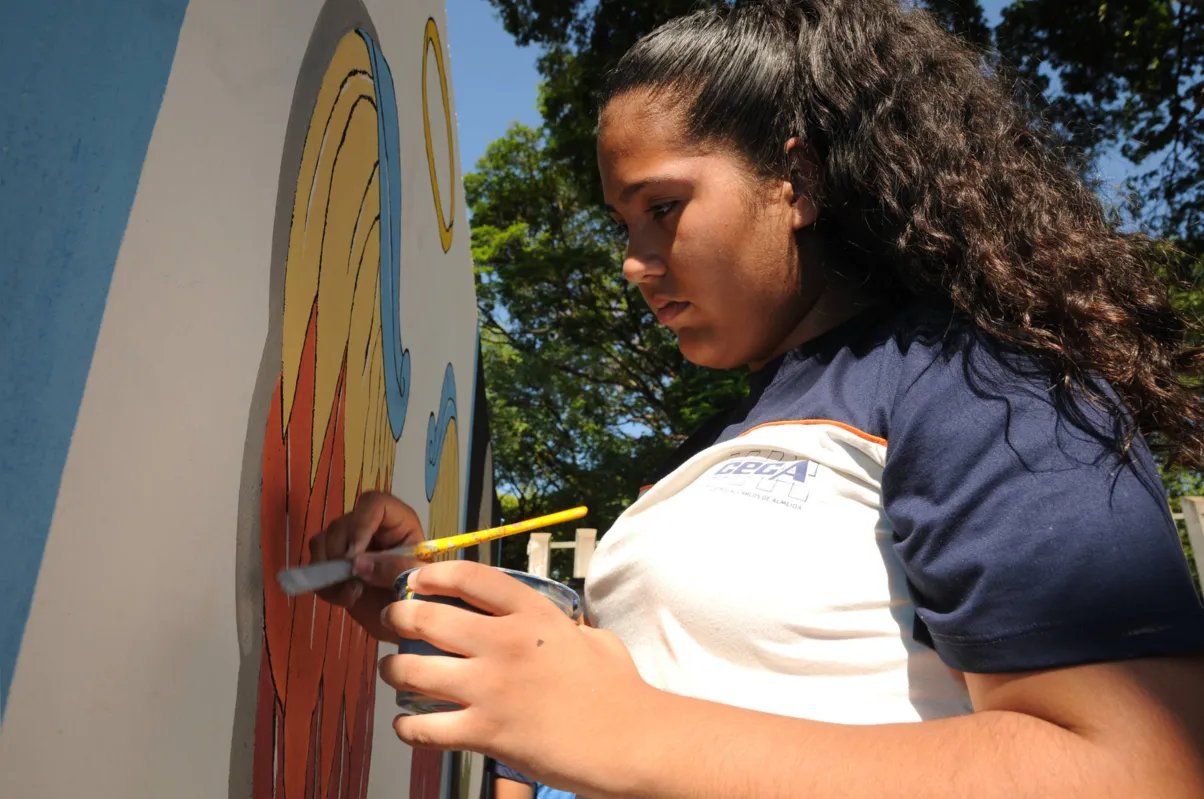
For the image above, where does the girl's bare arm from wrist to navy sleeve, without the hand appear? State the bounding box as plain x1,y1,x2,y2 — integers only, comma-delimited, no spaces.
606,657,1204,799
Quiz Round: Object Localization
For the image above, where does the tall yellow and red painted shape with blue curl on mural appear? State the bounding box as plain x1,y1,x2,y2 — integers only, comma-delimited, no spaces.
253,18,409,799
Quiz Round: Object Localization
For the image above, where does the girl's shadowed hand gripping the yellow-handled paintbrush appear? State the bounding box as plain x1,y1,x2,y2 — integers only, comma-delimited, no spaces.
309,491,424,641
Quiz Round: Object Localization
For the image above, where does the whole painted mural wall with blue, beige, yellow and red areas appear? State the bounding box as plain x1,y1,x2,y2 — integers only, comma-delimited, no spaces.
0,0,496,799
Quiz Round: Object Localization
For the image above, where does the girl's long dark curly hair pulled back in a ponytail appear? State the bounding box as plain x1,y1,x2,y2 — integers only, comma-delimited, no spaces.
602,0,1204,468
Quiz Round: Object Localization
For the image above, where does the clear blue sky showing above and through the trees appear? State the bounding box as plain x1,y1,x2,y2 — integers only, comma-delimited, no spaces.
447,0,1132,200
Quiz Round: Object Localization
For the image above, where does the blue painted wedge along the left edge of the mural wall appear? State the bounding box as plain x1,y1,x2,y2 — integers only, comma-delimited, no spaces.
0,0,188,718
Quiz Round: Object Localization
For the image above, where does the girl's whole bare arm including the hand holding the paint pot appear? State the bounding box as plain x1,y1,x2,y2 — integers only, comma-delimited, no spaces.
380,561,1204,799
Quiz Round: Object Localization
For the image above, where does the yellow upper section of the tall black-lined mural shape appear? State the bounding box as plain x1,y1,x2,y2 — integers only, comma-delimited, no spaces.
282,31,396,510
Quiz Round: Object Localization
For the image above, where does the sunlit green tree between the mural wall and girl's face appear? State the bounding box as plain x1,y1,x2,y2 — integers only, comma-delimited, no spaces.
465,125,744,564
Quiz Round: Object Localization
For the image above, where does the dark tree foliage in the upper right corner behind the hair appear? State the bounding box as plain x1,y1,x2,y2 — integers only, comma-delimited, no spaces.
997,0,1204,246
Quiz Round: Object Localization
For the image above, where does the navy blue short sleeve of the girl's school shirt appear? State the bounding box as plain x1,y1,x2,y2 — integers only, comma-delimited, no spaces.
883,334,1204,673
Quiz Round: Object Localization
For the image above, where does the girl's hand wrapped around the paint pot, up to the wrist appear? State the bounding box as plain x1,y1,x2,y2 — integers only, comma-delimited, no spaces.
380,561,655,793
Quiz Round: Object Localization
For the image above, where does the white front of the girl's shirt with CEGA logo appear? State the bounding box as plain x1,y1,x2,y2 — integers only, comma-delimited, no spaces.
586,422,970,724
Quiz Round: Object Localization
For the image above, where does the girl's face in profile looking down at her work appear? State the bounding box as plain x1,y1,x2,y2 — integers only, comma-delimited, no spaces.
598,91,825,368
